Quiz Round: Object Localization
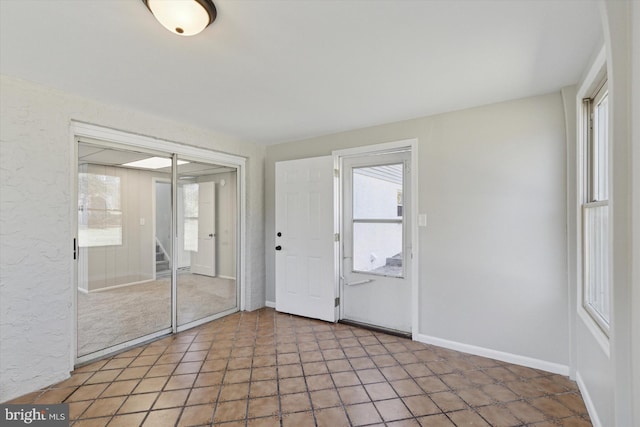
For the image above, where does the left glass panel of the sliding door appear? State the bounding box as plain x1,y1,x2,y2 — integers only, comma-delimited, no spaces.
77,143,171,357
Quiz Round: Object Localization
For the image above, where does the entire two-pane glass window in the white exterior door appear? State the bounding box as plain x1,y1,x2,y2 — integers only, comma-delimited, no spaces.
353,163,403,277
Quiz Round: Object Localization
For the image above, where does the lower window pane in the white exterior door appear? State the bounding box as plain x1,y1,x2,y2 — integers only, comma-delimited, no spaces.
353,222,402,277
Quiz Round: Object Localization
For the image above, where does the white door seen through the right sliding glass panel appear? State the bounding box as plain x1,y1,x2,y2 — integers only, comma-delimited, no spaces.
191,182,216,276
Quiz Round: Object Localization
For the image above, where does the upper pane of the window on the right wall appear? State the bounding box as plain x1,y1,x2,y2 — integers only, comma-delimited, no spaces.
593,95,609,200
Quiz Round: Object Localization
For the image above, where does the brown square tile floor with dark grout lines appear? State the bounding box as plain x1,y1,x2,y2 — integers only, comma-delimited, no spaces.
10,309,591,427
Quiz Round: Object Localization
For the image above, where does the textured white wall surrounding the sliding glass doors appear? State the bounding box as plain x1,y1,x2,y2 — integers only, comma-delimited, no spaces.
0,75,264,401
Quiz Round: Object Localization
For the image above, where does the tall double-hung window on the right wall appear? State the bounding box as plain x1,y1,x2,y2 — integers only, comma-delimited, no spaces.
582,82,611,333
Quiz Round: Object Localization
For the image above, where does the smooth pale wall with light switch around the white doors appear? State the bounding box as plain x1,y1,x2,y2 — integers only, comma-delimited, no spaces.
265,93,569,372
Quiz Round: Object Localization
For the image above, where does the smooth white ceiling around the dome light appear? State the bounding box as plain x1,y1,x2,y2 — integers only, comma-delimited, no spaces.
0,0,602,144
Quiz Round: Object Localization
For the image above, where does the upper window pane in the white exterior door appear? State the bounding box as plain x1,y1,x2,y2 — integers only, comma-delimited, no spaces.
353,163,403,219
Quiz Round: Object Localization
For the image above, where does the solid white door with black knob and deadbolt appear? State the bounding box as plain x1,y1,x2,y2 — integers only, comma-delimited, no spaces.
275,156,336,322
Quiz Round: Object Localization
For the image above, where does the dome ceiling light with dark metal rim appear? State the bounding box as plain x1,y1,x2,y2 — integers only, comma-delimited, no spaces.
142,0,218,36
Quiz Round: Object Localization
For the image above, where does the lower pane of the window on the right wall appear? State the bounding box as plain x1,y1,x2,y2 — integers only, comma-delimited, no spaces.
584,205,610,326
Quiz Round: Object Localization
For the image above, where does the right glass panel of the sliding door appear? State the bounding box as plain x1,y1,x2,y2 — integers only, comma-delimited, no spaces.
176,159,238,326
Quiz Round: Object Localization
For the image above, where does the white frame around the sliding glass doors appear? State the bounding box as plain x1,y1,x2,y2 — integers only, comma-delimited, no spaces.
69,120,247,370
